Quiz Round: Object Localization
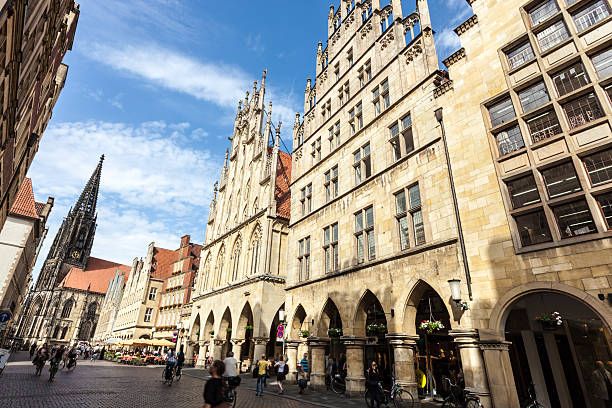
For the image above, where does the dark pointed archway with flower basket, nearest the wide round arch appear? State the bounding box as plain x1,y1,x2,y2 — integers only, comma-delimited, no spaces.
412,281,456,397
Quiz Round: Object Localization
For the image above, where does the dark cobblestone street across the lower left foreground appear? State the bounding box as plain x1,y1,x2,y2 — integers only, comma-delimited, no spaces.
0,353,334,408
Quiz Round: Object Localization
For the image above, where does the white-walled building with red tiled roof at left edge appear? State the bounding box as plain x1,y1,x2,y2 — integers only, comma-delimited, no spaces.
0,177,54,337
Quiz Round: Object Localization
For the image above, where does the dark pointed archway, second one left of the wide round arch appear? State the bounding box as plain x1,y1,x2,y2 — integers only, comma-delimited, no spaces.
354,290,393,384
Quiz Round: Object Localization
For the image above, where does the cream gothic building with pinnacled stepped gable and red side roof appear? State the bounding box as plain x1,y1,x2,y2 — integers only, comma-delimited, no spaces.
182,72,291,366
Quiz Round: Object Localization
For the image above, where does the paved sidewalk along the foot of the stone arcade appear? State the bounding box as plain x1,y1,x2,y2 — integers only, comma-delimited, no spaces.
183,368,441,408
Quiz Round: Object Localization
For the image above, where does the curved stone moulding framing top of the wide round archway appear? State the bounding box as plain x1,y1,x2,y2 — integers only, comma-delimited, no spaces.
489,282,612,333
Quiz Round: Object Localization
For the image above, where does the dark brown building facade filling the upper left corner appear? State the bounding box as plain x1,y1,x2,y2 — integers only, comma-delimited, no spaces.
0,0,79,233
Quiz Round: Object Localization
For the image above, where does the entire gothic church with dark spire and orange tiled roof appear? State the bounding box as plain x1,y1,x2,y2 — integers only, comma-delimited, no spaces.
17,156,129,344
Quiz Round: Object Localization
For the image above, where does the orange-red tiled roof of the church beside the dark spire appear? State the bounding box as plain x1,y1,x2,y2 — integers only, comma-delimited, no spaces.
59,257,130,294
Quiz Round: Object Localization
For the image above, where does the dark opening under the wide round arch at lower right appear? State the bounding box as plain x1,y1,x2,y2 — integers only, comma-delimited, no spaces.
502,290,612,408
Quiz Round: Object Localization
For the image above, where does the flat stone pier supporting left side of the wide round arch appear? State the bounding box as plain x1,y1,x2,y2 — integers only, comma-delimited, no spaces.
479,330,520,408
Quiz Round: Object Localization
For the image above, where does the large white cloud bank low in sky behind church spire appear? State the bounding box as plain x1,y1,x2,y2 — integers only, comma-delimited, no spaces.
28,121,222,272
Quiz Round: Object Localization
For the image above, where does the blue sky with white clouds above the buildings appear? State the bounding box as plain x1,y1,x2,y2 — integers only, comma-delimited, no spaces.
28,0,471,273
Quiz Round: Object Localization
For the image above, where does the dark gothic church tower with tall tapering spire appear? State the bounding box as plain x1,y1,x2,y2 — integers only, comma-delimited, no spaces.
36,155,104,290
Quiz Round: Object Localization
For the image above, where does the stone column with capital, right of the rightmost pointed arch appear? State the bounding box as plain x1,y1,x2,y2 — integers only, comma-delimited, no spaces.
448,329,497,408
